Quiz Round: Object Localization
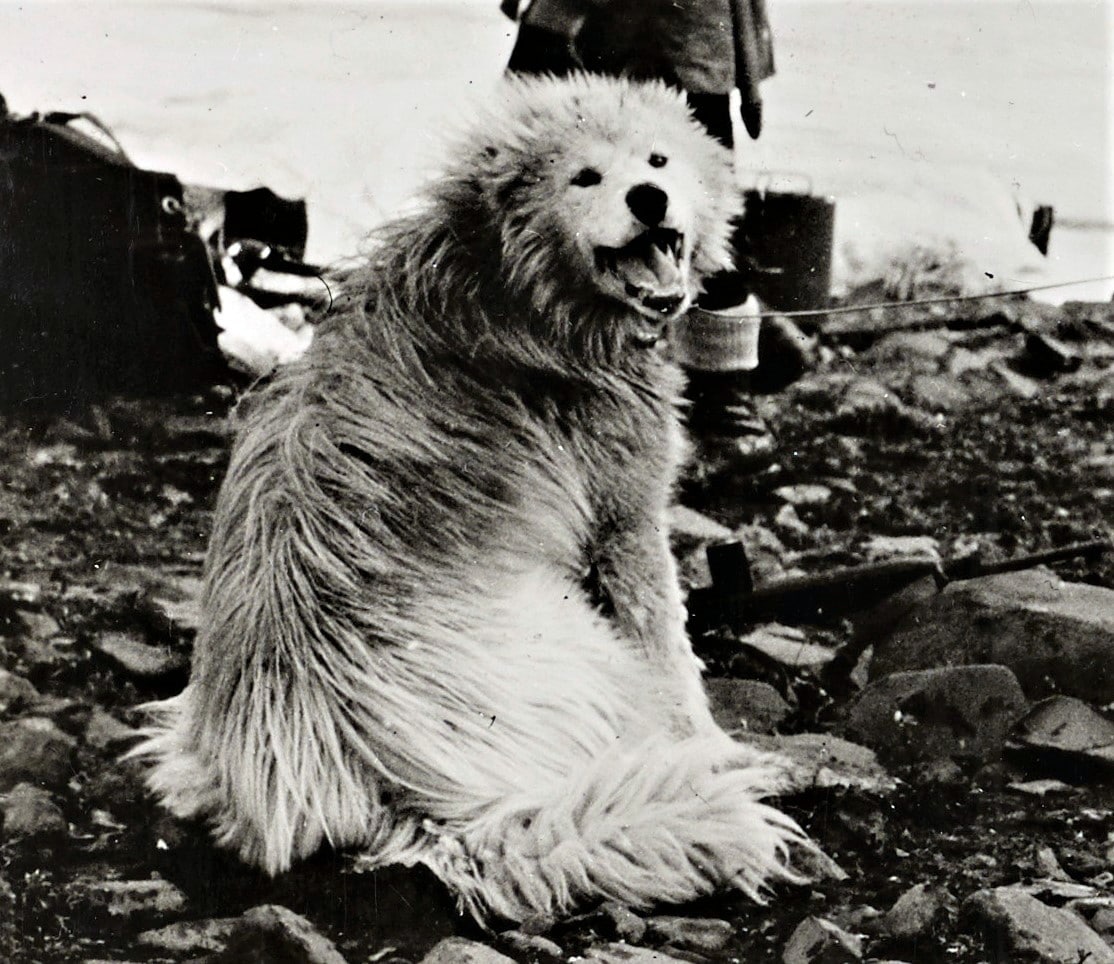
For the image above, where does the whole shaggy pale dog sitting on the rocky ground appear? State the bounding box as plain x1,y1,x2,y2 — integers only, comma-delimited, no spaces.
139,78,801,919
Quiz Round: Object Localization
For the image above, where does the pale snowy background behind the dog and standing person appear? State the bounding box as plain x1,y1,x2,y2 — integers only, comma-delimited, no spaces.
0,0,1114,300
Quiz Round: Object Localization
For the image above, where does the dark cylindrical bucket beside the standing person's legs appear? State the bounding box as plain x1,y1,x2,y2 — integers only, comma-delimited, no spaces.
743,180,836,311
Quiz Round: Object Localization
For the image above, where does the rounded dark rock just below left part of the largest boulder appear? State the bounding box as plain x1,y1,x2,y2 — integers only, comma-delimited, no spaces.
840,666,1028,765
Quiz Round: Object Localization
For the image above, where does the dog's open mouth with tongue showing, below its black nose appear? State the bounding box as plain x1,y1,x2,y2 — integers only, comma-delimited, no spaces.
595,227,692,344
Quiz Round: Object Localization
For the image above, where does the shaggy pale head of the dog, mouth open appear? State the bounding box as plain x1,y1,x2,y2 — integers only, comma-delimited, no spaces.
452,76,740,344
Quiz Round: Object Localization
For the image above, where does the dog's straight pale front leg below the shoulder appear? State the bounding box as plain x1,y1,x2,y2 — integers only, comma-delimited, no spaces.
595,519,715,736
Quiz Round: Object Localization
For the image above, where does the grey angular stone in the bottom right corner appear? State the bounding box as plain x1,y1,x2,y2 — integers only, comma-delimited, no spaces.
964,887,1114,964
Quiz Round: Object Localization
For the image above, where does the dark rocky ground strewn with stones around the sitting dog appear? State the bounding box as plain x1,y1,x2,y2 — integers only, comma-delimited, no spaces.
0,302,1114,964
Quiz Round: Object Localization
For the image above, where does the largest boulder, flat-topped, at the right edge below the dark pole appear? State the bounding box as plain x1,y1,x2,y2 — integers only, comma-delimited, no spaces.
870,569,1114,703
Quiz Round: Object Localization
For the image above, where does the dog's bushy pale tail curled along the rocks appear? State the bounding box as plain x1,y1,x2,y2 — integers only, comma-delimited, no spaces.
394,734,811,921
